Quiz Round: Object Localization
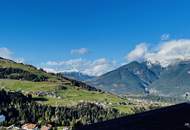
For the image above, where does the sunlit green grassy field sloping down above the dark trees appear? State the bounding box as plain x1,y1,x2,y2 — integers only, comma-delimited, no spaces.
0,79,132,113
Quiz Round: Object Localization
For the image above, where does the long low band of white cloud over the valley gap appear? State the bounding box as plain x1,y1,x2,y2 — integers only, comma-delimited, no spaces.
43,58,117,76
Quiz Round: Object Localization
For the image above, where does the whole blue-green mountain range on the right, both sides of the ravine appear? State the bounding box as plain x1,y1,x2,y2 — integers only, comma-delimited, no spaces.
89,61,190,97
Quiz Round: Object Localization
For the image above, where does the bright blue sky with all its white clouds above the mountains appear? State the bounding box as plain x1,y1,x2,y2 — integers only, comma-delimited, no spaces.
0,0,190,76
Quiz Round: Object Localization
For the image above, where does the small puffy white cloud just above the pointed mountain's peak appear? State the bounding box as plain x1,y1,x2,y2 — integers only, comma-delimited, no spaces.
126,43,148,62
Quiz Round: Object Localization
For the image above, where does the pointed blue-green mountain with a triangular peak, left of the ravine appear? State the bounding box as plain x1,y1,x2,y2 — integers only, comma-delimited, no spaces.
89,61,161,94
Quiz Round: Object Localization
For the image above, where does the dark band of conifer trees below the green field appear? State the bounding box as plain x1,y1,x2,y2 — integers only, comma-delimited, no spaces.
0,90,120,126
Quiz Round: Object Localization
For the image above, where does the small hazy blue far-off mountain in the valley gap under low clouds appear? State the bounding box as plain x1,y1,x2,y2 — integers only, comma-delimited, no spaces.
62,72,95,81
